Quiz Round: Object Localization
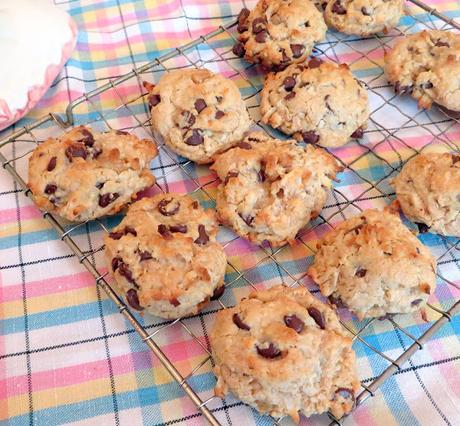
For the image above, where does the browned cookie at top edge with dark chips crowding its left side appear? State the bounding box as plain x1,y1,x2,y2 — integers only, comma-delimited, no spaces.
233,0,327,70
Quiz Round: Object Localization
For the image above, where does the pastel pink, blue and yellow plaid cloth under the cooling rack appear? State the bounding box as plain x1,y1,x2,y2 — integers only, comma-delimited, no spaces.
0,0,460,426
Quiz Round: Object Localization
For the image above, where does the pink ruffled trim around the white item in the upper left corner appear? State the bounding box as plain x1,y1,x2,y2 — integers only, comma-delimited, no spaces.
0,16,78,130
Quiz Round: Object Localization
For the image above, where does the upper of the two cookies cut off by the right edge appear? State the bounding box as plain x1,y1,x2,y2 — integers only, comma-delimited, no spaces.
385,30,460,112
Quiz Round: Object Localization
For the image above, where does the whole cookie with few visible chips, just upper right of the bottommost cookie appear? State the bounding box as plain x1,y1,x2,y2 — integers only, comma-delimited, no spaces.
308,210,436,319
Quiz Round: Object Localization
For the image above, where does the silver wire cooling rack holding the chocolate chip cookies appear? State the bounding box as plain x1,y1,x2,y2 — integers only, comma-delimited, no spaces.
0,0,460,425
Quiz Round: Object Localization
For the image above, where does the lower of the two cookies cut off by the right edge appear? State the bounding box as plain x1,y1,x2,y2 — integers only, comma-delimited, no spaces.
392,153,460,237
